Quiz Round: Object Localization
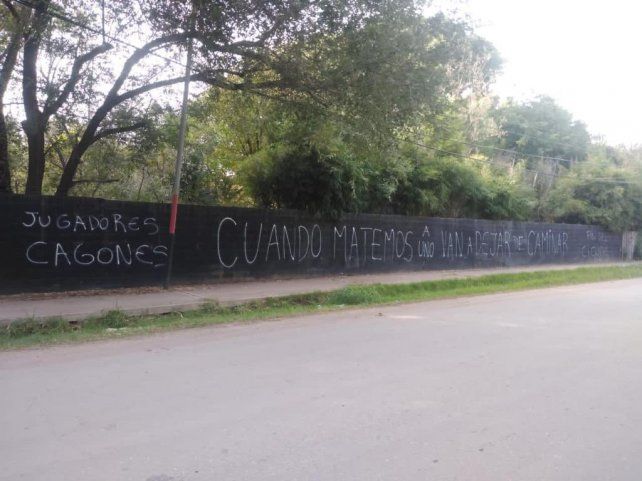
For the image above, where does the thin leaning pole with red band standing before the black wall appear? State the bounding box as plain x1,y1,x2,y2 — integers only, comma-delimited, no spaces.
165,34,192,289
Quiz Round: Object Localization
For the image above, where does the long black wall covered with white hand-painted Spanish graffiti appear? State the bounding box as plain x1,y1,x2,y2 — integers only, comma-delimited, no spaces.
0,196,622,292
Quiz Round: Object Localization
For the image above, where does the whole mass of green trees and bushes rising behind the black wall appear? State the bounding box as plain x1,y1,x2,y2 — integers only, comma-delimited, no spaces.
0,0,642,238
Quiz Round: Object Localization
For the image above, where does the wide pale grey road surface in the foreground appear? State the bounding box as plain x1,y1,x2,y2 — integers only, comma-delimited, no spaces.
0,280,642,481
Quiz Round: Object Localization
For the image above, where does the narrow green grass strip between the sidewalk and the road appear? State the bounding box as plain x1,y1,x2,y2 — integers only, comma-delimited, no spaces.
0,264,642,350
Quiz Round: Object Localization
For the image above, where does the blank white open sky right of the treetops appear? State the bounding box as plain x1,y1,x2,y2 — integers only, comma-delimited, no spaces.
435,0,642,146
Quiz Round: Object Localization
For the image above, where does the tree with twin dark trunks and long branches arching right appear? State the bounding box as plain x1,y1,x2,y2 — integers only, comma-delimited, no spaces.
8,0,444,195
